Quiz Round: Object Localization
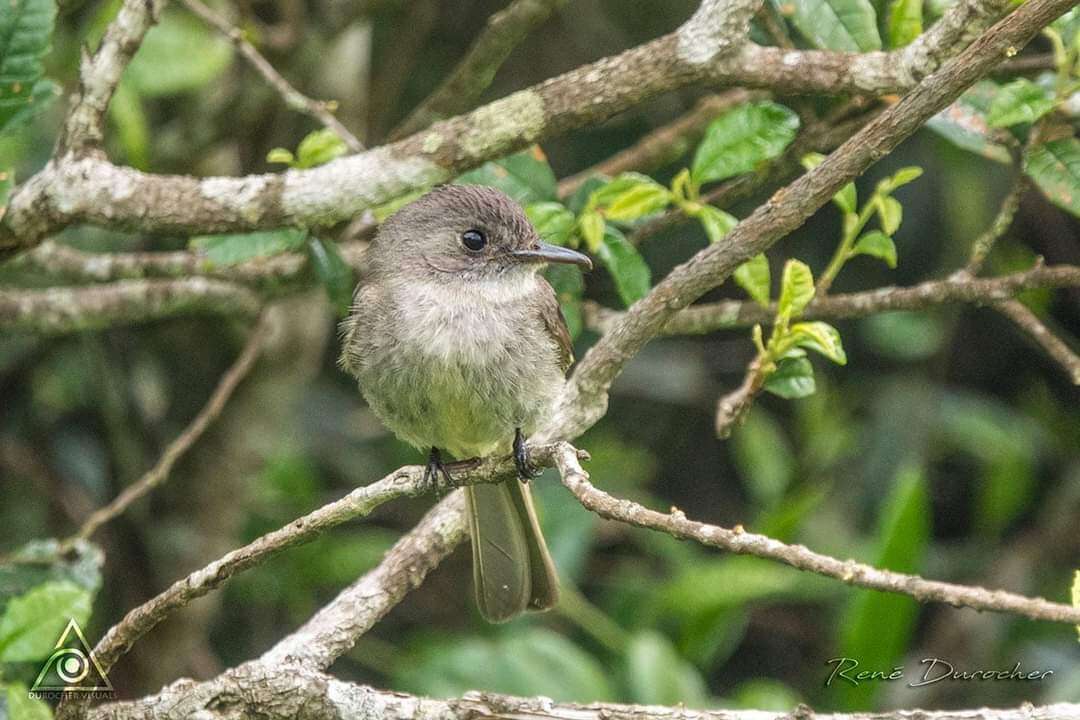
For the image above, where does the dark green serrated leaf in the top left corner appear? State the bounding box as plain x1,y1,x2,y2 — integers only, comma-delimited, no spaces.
0,0,56,133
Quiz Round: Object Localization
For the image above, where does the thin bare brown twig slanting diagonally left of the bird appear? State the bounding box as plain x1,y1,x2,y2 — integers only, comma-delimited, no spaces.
63,314,271,547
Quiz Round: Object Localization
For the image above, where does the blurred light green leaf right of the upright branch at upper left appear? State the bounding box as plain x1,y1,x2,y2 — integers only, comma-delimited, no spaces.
124,10,232,97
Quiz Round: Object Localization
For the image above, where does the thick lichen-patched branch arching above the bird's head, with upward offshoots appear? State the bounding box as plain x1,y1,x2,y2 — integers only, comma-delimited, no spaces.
0,0,1003,259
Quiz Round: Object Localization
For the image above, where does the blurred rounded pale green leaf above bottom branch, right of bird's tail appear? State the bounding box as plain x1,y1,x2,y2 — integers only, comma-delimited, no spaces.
626,630,708,707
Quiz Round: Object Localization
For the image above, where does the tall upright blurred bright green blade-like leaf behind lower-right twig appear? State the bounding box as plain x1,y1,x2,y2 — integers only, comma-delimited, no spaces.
834,467,931,709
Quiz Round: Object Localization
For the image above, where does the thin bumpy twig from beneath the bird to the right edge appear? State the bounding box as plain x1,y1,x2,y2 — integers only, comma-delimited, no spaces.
555,443,1080,624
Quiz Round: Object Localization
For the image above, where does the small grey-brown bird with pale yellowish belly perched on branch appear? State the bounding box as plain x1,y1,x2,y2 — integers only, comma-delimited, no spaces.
340,185,592,623
